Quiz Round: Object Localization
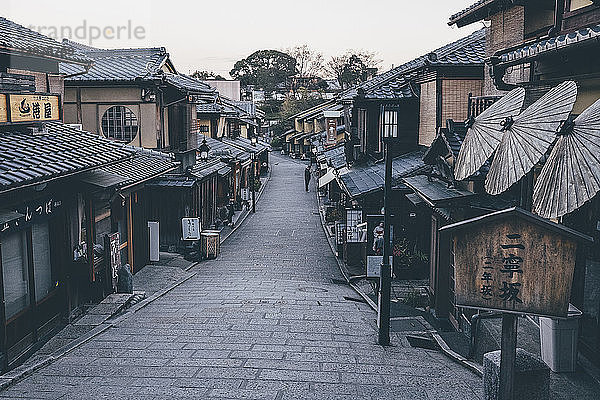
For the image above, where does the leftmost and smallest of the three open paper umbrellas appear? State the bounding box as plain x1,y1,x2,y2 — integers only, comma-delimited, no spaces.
454,88,525,181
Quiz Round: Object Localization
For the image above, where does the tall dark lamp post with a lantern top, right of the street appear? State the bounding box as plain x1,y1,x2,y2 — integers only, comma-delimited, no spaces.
377,113,398,346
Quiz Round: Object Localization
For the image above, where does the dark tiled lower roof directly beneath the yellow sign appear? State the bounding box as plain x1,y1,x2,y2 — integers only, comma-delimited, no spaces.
0,122,133,191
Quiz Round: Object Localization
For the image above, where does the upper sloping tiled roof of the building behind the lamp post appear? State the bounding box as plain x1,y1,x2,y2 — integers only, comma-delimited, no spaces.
340,28,485,100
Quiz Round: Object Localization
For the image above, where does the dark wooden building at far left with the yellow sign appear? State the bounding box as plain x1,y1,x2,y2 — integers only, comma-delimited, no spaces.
0,18,152,370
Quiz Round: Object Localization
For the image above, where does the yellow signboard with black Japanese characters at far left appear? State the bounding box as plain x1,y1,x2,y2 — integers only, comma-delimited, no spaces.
5,94,61,123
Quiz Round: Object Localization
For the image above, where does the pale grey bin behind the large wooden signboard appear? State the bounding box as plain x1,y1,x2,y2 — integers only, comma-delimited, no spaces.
540,304,582,372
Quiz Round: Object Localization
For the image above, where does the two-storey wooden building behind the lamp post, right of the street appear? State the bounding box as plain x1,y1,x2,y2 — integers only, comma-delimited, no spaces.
323,30,485,277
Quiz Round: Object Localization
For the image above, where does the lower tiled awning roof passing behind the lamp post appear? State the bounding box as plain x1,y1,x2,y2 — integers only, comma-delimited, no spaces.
339,150,426,198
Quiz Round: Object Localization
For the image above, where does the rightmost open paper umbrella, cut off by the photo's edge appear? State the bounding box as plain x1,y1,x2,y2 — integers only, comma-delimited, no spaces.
533,100,600,218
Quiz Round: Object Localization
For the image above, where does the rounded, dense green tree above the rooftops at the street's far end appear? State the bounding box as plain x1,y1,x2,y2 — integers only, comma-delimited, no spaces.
229,50,296,93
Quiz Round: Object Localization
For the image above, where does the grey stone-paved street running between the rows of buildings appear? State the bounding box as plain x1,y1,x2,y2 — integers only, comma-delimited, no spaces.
0,156,481,400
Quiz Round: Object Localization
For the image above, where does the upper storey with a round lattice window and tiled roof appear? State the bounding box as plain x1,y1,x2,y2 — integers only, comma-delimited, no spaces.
61,41,216,152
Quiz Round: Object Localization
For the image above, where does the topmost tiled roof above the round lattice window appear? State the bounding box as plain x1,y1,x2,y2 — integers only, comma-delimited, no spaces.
60,41,169,82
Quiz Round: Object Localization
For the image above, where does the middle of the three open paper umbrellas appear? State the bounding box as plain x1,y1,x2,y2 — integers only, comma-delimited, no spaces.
485,81,577,195
